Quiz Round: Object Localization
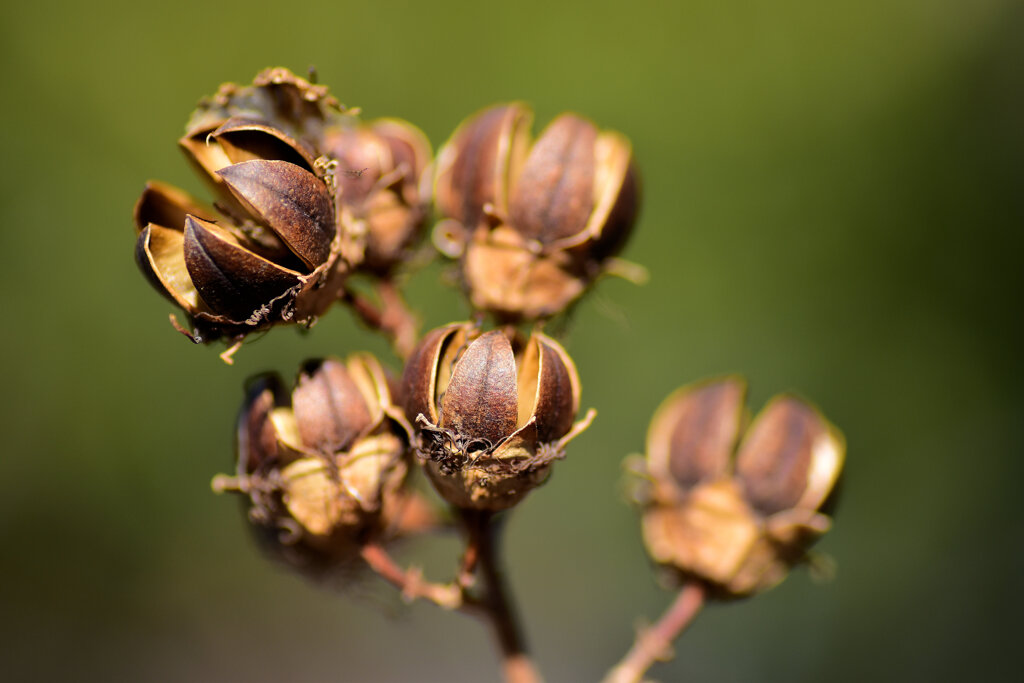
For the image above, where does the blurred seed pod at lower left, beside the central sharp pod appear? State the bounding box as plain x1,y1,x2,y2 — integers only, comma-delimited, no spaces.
213,354,424,574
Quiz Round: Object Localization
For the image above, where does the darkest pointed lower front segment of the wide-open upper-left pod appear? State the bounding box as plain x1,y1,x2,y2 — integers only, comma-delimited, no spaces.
184,216,301,322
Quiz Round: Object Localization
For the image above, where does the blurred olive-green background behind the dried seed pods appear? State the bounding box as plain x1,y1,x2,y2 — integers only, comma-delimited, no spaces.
0,0,1024,681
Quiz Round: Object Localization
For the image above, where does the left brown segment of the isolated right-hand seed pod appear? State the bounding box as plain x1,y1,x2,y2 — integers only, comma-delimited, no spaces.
647,377,745,490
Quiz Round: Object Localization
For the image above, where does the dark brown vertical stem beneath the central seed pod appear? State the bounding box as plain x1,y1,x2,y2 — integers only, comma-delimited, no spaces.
461,510,543,683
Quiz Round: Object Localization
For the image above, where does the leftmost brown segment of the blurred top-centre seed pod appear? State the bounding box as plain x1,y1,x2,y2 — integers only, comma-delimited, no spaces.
434,103,530,231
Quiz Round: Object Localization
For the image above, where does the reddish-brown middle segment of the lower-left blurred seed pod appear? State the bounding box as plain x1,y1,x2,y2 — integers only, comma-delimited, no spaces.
292,359,372,455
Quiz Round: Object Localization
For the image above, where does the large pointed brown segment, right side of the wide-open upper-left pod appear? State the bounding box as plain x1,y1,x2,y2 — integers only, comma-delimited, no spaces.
217,160,335,268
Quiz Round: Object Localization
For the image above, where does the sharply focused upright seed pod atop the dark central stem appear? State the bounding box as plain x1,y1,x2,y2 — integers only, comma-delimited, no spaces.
402,323,595,511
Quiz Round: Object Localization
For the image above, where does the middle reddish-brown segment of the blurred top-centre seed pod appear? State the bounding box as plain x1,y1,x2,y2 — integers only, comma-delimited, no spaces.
509,114,597,245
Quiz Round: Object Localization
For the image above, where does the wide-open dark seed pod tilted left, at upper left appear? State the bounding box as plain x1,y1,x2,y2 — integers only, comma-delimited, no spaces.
134,70,351,358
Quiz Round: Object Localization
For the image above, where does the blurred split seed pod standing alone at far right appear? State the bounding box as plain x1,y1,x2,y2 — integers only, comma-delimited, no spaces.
643,377,846,597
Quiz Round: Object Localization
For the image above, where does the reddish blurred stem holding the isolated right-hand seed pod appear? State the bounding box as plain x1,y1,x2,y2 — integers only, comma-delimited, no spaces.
604,582,705,683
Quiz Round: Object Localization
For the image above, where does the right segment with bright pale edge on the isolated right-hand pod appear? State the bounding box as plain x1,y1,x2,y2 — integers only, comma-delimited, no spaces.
736,396,845,515
